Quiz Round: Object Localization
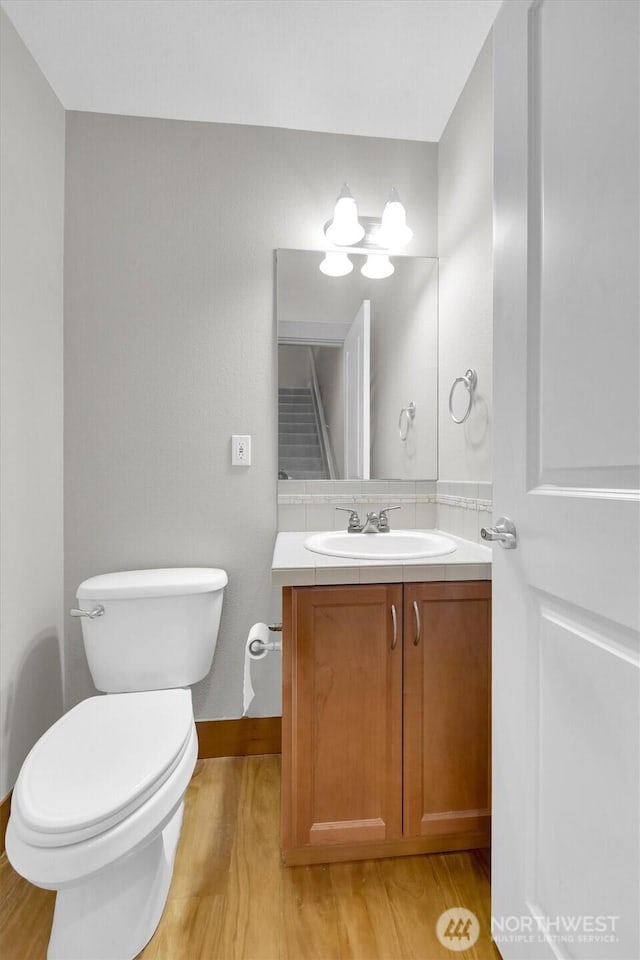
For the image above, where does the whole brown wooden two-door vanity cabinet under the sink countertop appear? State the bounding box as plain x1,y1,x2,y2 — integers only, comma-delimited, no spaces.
282,581,491,864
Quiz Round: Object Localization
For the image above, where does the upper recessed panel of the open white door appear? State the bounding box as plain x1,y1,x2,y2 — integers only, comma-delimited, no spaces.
526,0,640,491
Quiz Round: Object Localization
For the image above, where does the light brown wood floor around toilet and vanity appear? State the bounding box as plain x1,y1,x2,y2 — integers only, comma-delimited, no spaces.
0,756,499,960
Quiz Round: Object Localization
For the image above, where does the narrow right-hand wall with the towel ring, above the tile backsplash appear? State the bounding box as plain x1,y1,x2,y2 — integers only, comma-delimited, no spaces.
438,36,493,480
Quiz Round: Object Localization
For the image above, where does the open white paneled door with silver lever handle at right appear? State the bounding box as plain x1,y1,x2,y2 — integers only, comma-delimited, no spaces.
492,0,640,960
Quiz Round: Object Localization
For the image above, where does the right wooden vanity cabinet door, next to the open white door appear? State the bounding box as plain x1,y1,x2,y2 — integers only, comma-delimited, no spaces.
404,581,491,845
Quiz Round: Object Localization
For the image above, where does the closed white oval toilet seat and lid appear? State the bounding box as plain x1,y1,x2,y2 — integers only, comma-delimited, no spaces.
13,689,193,848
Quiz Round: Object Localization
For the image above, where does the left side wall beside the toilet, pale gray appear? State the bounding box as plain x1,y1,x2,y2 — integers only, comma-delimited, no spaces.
0,10,65,799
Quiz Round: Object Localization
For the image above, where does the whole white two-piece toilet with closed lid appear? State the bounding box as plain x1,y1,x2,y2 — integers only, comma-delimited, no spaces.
6,568,227,960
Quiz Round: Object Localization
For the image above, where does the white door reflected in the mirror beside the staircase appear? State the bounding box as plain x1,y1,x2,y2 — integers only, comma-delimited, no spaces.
343,300,371,480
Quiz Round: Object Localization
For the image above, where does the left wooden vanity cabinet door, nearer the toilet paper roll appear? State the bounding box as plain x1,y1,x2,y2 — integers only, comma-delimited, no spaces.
282,584,402,852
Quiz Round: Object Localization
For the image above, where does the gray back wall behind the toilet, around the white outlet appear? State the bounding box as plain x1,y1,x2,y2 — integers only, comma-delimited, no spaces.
65,113,437,718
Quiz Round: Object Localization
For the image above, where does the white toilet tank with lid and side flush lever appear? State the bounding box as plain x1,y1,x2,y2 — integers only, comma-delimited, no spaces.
76,567,227,693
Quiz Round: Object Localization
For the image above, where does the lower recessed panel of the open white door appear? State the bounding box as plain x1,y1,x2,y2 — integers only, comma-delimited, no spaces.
525,591,640,960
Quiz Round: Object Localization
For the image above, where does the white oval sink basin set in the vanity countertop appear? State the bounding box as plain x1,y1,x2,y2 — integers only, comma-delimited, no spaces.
304,530,456,560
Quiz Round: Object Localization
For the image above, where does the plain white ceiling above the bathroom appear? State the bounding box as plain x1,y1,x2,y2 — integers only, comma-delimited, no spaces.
1,0,502,141
